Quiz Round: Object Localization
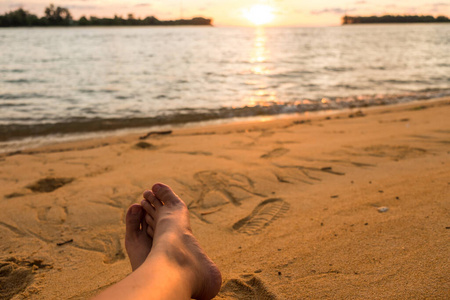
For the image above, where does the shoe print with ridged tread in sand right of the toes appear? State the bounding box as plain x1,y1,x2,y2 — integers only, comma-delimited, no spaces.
233,198,289,235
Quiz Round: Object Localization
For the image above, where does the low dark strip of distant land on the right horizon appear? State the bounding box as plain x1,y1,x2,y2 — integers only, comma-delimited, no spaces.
342,15,450,25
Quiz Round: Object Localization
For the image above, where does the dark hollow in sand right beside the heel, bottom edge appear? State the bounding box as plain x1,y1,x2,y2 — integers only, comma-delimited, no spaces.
217,274,276,300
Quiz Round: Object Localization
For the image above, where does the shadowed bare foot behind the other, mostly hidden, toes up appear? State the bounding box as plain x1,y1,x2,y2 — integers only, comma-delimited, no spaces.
125,204,153,271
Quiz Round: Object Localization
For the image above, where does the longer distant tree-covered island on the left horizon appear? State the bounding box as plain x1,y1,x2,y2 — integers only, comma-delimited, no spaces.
0,4,212,27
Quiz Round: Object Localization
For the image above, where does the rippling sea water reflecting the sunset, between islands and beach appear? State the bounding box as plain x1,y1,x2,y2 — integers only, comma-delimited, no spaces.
0,24,450,141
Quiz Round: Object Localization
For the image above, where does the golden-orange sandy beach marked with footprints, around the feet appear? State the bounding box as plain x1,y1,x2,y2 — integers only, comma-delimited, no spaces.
0,98,450,299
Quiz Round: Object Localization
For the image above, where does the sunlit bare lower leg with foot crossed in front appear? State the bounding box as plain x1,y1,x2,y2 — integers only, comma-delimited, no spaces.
96,184,222,299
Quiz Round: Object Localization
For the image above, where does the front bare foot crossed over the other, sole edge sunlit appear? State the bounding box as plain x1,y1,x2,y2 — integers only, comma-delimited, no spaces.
141,183,222,299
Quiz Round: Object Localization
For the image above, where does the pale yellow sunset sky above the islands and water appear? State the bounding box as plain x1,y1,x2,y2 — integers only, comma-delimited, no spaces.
0,0,450,26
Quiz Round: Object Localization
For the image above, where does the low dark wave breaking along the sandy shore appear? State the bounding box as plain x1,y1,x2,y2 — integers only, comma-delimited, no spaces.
0,89,450,142
